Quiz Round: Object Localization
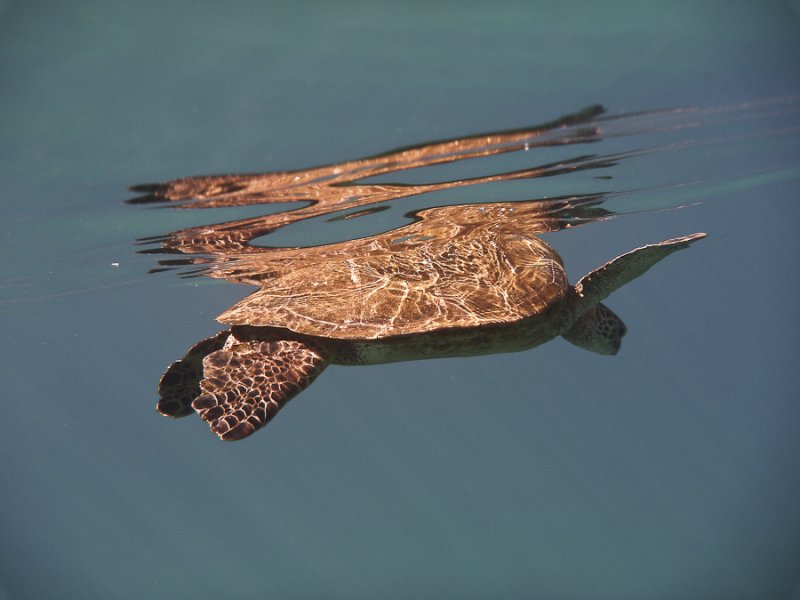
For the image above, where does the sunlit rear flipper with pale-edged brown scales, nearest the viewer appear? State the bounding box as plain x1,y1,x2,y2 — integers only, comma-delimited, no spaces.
192,335,329,440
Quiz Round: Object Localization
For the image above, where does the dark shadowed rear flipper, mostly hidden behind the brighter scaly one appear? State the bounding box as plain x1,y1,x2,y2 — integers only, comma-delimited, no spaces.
156,329,230,417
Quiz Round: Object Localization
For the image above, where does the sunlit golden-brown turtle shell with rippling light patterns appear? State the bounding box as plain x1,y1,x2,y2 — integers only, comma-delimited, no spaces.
218,206,568,339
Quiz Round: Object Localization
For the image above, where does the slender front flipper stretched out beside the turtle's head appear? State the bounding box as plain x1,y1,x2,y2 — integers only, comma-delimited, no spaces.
575,233,706,310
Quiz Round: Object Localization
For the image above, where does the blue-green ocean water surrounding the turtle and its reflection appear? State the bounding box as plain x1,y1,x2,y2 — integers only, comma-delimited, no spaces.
0,0,800,600
